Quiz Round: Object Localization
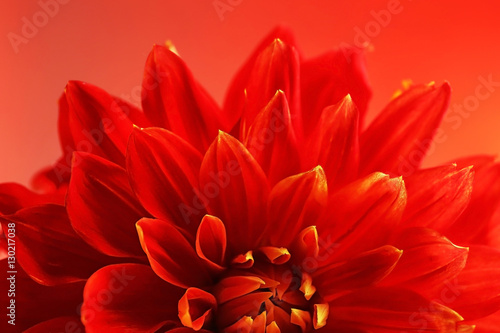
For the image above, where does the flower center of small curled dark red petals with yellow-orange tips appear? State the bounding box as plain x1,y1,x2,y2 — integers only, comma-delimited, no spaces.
180,247,328,333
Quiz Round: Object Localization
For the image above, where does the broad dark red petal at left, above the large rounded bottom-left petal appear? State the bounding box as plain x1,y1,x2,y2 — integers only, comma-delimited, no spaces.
66,152,148,257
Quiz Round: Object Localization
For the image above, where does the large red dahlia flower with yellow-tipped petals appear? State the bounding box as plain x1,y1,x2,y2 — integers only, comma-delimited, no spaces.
1,29,500,333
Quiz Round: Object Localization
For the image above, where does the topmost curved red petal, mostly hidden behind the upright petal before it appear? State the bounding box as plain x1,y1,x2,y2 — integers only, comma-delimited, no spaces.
224,27,295,130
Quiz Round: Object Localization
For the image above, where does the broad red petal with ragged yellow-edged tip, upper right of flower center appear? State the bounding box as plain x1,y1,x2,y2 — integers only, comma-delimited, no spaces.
318,173,406,260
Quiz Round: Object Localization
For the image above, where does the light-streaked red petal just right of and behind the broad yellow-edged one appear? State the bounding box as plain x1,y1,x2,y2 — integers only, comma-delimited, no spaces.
401,165,474,231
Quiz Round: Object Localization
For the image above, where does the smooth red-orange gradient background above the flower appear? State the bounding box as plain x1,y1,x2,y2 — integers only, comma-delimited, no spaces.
0,0,500,184
